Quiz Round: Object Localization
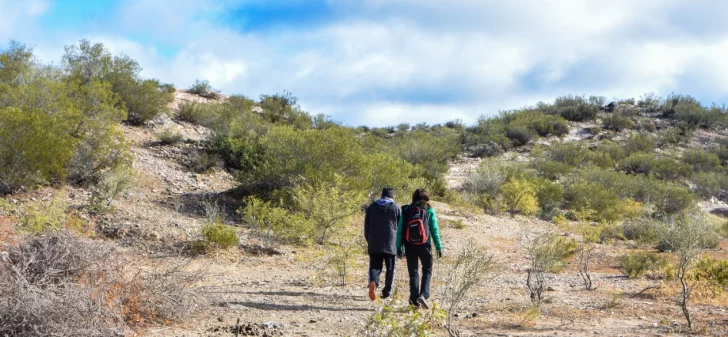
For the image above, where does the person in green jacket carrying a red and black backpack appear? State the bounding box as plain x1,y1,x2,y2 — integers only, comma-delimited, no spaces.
396,188,442,308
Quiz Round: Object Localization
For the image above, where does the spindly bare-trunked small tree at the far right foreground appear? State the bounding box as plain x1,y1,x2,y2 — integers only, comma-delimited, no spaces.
660,212,716,330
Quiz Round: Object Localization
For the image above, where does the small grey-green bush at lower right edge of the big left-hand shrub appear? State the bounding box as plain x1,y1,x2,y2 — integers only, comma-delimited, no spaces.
89,166,136,212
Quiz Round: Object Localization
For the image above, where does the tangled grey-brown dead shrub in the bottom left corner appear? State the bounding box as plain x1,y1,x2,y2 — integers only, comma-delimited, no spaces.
0,231,199,337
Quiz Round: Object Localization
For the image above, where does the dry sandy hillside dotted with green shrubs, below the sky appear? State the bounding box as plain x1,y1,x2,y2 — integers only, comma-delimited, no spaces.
0,43,728,336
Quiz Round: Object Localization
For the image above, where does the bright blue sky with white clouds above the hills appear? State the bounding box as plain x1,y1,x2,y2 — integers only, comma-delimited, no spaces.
0,0,728,126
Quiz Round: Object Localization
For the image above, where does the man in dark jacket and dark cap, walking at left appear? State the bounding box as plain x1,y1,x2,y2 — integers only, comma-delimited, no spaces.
364,188,402,301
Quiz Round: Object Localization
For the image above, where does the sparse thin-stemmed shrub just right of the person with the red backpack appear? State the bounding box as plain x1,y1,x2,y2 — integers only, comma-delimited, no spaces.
443,241,494,337
